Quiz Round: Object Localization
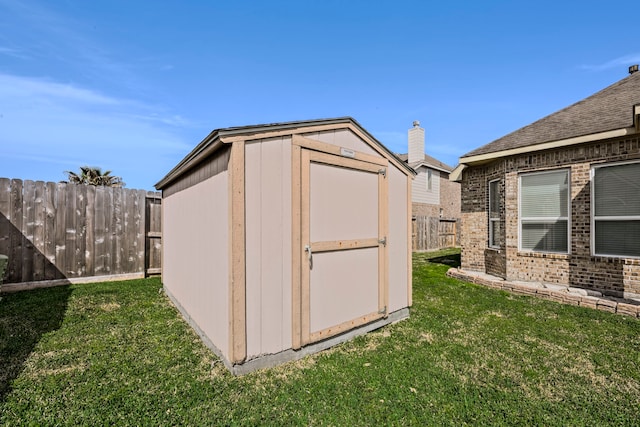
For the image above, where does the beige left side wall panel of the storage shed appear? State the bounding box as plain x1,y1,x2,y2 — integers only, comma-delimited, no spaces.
162,166,229,359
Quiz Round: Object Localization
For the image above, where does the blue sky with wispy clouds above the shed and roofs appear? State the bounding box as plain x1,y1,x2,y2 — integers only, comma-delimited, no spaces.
0,0,640,190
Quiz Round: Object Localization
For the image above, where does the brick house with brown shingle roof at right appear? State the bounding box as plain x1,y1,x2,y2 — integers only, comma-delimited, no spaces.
451,66,640,297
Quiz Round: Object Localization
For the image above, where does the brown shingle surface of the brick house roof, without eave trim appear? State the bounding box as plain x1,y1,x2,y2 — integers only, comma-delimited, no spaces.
462,72,640,158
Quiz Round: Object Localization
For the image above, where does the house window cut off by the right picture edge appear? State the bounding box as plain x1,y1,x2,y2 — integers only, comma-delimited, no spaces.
591,162,640,257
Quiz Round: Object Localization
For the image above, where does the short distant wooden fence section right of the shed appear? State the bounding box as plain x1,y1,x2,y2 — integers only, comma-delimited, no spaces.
412,215,460,251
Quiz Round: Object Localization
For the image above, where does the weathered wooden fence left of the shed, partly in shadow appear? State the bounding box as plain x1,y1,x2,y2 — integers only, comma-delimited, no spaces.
0,178,161,284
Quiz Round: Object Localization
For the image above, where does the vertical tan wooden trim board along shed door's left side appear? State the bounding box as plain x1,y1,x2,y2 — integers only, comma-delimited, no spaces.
291,145,302,350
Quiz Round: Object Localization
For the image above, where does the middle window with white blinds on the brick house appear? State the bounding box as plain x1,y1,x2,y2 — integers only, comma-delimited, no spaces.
519,170,571,253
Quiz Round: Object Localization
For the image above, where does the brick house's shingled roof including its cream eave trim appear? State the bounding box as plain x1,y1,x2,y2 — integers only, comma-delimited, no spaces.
452,72,640,179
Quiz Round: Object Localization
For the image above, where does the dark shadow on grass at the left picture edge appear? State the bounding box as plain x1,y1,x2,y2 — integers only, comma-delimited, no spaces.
0,286,71,402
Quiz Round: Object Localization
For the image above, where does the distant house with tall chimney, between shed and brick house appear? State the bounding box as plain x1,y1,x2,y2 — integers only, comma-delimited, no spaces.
398,121,460,219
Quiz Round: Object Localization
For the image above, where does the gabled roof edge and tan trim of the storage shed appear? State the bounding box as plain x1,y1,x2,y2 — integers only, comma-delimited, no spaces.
155,117,416,190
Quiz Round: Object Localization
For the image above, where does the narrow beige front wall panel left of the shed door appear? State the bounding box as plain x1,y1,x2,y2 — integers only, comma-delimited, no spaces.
245,137,292,359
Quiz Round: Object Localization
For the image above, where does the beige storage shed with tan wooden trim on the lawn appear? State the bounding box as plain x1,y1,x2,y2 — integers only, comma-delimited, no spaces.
156,117,415,374
